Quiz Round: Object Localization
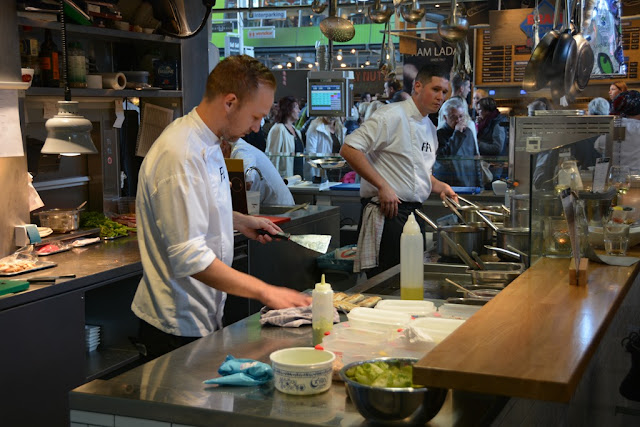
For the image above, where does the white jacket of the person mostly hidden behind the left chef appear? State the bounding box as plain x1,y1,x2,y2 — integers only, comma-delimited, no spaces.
231,139,295,206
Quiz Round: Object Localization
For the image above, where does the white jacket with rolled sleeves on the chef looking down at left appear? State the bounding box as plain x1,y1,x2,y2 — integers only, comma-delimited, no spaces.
131,108,233,337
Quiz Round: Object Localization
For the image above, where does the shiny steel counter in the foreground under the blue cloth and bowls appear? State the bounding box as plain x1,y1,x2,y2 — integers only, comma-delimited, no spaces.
70,315,506,427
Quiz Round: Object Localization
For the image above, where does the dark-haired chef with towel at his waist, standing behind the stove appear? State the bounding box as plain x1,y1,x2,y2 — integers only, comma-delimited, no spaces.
340,66,458,276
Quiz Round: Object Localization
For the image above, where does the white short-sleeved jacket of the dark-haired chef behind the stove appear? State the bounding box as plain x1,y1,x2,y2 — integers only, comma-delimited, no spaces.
345,98,438,202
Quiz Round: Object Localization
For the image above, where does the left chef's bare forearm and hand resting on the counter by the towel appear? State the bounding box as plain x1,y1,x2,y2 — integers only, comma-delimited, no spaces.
192,258,311,309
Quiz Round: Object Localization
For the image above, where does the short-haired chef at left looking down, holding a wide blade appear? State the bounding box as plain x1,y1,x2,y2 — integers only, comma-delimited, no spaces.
131,55,311,359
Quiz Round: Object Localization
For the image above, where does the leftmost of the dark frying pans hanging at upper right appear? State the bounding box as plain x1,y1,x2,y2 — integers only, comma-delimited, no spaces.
522,0,560,91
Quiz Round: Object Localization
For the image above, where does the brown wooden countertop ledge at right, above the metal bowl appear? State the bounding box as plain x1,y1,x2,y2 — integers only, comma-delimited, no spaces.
414,248,640,402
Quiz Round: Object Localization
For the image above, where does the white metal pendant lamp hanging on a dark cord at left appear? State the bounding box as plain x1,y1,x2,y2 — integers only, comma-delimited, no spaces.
40,0,98,156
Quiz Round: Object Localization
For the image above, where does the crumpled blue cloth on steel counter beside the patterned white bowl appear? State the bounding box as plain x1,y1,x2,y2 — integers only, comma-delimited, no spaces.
204,355,273,387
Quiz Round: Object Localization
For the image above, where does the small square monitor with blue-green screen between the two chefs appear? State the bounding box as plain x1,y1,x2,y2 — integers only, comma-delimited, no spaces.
307,78,348,117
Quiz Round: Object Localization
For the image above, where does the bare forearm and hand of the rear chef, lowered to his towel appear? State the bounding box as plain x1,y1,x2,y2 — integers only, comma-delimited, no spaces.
340,144,401,218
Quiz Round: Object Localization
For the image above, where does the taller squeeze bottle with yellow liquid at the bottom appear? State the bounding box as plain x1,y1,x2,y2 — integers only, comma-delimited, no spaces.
400,213,424,300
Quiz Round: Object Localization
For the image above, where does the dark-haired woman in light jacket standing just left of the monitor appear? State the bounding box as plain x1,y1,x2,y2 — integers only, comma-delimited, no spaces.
266,96,304,177
